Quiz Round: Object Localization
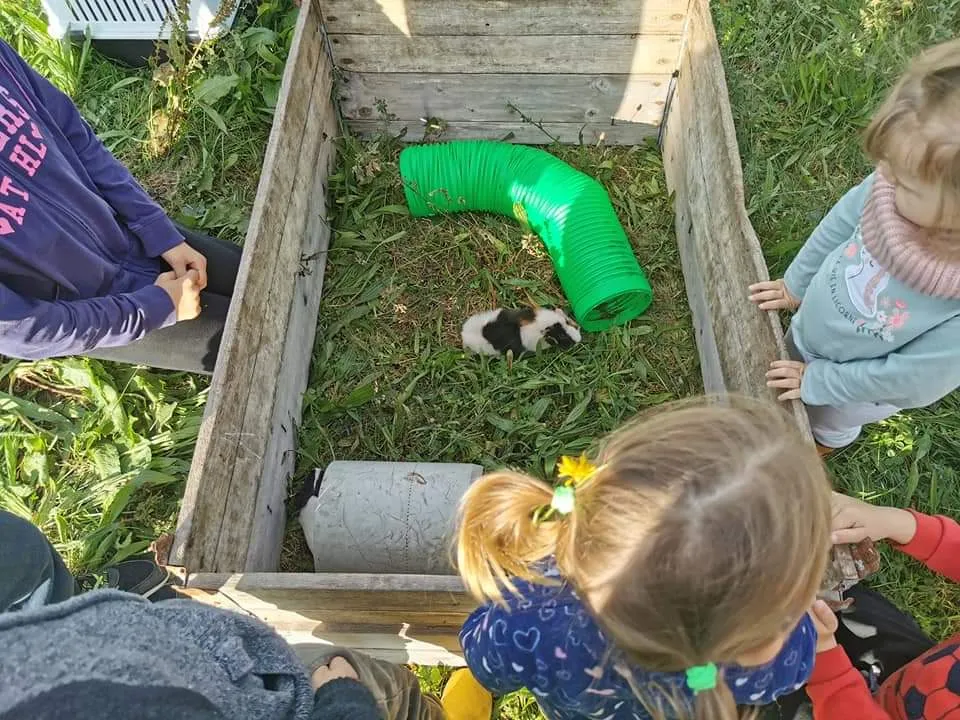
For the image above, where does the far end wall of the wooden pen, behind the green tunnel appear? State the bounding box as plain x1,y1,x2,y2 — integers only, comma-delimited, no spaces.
320,0,689,145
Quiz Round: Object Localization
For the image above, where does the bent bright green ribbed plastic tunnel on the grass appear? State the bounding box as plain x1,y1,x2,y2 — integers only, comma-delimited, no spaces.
400,141,653,331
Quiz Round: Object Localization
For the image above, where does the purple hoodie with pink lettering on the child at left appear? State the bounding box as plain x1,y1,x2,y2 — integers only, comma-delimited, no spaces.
0,41,183,359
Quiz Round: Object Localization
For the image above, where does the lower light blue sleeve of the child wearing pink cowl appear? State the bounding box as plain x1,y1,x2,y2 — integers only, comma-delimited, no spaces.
800,316,960,407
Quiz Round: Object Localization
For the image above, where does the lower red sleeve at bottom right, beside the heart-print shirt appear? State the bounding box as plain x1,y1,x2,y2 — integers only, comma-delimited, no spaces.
807,645,893,720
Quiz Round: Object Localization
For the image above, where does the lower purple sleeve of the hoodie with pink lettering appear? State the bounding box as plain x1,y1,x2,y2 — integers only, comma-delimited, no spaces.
0,284,176,360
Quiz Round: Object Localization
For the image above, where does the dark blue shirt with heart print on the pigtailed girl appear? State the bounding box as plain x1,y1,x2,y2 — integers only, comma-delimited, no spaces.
460,571,817,720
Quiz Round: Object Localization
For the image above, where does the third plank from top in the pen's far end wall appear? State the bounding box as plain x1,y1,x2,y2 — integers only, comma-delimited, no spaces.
339,72,670,125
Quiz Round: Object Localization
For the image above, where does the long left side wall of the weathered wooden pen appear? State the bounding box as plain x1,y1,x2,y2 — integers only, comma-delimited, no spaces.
171,0,337,570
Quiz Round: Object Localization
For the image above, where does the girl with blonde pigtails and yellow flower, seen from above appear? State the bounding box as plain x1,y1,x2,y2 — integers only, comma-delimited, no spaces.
457,398,831,720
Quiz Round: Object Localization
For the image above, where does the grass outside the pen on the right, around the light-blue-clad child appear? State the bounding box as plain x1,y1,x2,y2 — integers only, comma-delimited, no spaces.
713,0,960,638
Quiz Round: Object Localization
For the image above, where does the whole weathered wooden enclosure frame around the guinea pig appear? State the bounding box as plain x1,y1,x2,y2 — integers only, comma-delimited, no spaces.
171,0,806,664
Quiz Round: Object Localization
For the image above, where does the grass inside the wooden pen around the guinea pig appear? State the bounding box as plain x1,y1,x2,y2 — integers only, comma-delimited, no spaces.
285,135,701,569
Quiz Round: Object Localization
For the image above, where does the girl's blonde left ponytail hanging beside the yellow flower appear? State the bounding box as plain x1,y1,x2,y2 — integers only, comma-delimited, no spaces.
457,472,566,605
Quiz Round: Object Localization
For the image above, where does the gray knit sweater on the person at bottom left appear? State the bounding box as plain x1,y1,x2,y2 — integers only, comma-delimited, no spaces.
0,590,314,720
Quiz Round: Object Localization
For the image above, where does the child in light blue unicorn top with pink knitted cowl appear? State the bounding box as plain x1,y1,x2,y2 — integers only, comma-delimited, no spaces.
750,39,960,451
